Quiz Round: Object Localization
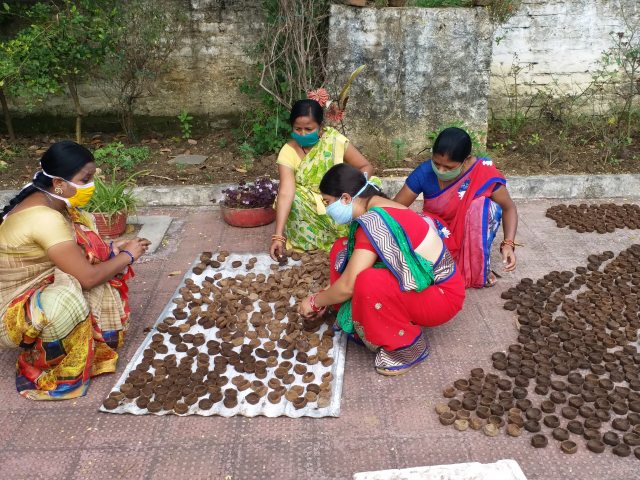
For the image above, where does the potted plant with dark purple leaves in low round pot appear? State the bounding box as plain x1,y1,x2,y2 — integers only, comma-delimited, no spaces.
220,177,278,228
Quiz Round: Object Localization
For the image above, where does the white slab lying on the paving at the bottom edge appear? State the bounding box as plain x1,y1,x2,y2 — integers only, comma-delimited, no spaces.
353,460,527,480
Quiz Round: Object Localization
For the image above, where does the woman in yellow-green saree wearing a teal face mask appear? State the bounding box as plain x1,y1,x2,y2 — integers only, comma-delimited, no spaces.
270,99,373,259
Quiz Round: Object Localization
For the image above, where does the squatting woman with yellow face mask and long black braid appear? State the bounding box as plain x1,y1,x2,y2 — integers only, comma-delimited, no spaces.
0,141,149,400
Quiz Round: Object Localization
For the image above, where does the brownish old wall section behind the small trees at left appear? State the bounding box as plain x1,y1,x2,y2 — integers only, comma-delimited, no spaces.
8,0,263,123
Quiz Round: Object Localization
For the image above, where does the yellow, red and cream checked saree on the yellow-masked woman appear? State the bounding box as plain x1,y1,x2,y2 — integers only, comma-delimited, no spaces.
0,210,133,400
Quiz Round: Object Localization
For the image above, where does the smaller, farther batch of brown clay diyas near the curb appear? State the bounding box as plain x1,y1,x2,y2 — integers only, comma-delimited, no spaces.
546,203,640,233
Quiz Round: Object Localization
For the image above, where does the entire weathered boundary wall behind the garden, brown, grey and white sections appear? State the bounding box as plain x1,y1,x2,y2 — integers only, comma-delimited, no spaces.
6,0,640,136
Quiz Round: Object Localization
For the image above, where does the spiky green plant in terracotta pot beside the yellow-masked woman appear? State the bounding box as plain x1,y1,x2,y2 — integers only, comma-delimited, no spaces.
85,169,144,238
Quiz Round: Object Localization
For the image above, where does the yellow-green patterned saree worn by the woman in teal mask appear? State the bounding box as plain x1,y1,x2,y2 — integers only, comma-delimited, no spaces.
284,127,349,251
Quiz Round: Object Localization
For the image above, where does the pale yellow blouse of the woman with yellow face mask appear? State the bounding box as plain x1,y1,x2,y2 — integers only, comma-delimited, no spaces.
0,205,75,256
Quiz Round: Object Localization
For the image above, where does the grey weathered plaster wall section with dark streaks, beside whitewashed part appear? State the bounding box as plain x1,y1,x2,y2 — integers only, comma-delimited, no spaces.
328,5,493,155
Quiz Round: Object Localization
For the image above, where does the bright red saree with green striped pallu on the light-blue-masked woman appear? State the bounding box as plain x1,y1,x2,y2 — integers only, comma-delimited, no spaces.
329,208,465,351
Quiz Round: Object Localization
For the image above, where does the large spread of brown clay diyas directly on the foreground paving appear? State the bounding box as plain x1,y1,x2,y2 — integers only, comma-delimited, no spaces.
437,245,640,457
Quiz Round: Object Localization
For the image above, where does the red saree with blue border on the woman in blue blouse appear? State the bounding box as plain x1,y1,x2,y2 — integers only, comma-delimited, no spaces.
423,158,507,288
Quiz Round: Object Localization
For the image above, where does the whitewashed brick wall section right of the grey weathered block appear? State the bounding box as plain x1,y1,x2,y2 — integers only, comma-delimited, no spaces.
490,0,640,110
